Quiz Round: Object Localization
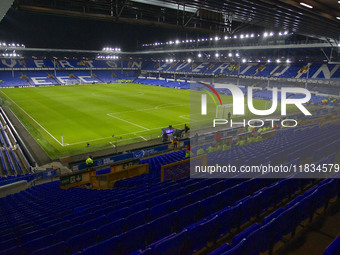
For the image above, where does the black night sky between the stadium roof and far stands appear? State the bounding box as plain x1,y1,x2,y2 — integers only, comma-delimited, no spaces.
0,8,202,51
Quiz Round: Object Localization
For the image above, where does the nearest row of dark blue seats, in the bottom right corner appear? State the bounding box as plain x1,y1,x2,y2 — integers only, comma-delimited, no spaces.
210,172,340,255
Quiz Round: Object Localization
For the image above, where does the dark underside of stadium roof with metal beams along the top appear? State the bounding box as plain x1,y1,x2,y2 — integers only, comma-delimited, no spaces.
15,0,340,40
